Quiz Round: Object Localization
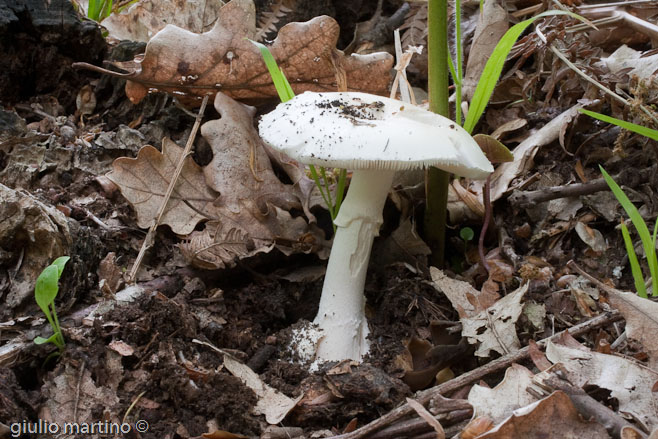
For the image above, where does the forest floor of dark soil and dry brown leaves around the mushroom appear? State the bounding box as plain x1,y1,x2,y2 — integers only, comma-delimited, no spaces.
0,0,658,439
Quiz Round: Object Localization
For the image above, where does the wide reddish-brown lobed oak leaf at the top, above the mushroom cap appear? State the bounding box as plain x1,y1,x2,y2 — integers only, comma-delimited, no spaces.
115,0,393,103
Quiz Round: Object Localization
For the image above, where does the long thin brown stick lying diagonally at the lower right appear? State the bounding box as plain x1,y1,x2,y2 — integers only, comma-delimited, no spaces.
334,310,623,439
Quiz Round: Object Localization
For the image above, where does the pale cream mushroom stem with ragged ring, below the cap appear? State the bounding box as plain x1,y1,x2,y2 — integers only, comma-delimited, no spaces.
314,170,395,363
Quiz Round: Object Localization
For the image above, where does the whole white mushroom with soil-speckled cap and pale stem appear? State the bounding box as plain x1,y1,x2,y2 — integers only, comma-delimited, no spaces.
259,92,493,363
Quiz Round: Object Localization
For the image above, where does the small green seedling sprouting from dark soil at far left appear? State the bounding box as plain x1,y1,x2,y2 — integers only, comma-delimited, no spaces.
34,256,70,353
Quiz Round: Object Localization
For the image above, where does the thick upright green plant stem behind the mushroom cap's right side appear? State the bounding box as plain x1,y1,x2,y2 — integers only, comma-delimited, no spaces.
424,0,450,267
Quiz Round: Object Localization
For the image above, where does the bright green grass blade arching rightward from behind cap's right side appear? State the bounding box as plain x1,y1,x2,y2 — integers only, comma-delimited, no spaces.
464,11,589,134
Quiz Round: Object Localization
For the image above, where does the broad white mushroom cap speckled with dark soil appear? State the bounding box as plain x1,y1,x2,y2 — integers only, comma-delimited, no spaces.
258,92,493,178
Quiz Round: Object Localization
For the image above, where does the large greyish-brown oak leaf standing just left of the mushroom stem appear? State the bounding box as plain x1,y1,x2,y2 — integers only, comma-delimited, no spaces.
180,93,324,269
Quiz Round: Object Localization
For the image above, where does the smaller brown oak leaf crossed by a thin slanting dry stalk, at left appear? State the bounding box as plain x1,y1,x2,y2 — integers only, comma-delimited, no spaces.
107,138,218,235
